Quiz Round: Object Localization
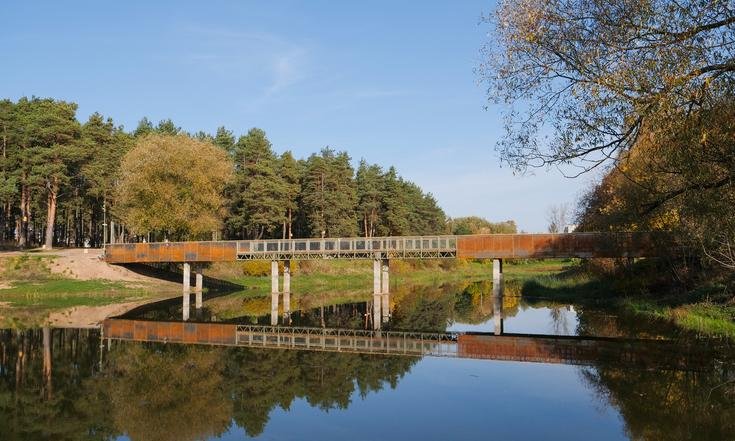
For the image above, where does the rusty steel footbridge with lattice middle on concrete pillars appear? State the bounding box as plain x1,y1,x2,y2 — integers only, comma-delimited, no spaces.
103,232,660,319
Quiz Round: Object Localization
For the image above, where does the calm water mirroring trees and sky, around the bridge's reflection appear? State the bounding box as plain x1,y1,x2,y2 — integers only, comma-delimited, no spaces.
0,283,735,440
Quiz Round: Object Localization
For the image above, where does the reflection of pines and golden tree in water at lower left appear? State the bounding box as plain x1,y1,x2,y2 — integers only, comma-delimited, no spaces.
0,330,416,440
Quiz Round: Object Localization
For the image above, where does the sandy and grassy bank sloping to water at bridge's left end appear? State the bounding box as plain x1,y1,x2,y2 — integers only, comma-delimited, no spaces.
0,249,180,327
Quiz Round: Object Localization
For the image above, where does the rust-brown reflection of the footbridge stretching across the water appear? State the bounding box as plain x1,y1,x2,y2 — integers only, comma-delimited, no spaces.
103,319,717,370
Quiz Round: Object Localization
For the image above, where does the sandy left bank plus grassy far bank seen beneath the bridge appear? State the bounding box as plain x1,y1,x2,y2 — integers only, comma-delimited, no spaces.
0,250,571,327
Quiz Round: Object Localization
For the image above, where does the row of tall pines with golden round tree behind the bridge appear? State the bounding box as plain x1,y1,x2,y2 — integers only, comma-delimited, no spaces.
0,97,447,248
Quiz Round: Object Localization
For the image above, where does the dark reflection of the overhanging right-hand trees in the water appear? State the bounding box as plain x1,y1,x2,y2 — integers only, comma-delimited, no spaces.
577,307,735,440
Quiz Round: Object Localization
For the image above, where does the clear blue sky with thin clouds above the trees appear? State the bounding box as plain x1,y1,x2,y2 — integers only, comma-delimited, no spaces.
0,0,591,231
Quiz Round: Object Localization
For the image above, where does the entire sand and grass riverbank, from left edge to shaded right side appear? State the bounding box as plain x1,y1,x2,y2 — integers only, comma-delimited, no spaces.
0,250,735,337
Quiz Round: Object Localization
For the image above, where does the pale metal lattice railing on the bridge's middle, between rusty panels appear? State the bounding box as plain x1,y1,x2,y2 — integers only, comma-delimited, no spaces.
237,236,457,259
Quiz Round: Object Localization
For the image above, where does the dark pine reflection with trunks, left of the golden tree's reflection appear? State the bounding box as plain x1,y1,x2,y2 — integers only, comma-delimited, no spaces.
0,329,113,440
